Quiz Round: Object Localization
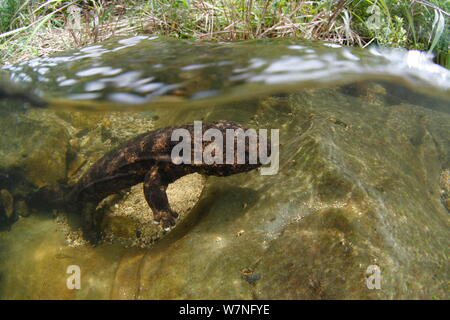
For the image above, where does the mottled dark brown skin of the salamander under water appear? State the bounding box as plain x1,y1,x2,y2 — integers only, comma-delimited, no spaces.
29,121,260,244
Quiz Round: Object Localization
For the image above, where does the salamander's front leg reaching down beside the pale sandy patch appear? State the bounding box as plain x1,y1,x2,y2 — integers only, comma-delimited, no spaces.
144,167,178,229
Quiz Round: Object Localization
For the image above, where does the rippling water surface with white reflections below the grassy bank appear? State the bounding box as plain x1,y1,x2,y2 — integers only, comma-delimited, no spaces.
3,36,450,109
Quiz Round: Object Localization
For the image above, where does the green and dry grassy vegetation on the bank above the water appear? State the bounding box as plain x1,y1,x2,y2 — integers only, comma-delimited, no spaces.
0,0,450,68
